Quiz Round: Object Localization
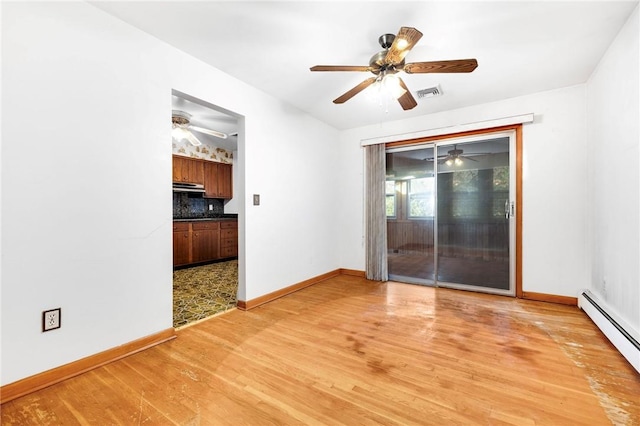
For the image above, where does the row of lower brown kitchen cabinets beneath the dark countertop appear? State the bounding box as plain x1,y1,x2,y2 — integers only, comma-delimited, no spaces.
173,220,238,267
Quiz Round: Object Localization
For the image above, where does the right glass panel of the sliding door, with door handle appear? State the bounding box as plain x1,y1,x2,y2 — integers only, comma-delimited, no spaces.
436,137,511,290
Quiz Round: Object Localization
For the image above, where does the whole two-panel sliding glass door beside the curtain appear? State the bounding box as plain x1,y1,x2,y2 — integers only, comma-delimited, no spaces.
387,133,515,294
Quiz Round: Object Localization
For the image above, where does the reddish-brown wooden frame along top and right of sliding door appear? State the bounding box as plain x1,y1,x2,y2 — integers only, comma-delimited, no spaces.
385,124,523,299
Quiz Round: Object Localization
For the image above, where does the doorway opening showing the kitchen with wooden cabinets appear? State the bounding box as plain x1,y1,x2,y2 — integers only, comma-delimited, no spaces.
171,90,244,328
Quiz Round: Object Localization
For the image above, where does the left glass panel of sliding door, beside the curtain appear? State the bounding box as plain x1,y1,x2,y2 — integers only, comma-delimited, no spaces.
386,147,436,284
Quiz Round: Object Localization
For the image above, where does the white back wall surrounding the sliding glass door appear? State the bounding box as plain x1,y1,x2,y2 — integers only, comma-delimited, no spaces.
340,85,588,297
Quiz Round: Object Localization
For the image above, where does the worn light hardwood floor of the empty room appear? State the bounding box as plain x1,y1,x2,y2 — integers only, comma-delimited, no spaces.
1,275,640,425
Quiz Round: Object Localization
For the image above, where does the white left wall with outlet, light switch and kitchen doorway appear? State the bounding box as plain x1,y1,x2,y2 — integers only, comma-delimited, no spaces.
0,2,340,385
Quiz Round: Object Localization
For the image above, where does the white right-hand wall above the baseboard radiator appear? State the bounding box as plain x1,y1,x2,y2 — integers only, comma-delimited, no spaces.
585,3,640,339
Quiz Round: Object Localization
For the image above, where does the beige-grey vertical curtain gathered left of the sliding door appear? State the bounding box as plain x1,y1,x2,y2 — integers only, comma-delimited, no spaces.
365,144,389,281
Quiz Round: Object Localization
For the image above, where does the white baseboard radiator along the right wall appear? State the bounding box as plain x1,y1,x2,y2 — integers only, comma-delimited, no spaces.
578,290,640,373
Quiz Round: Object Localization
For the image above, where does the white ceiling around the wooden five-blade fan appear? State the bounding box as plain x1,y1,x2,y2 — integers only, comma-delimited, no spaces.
91,0,638,133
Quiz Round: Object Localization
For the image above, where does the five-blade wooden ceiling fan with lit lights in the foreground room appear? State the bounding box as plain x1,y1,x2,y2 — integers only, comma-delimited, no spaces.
310,27,478,110
